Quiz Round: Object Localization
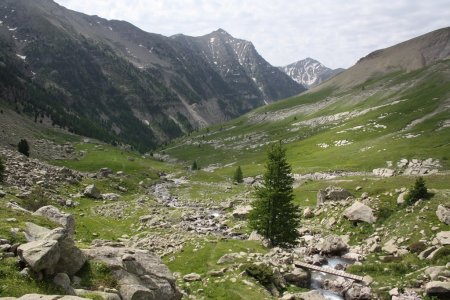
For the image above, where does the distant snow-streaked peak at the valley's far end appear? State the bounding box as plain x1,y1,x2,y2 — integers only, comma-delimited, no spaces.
280,57,344,88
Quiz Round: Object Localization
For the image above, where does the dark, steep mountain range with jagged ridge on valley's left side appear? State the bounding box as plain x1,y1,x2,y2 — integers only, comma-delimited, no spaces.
0,0,305,150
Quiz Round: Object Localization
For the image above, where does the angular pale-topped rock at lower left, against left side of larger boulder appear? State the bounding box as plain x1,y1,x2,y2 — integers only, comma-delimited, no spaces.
18,240,60,274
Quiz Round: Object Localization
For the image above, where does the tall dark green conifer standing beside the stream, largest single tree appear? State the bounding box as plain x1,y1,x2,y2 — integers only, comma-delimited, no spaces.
249,142,300,247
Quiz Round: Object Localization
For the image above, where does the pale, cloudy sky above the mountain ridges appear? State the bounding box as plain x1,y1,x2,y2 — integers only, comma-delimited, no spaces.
55,0,450,68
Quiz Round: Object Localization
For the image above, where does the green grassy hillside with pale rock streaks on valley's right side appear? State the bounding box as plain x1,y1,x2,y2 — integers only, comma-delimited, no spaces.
164,60,450,175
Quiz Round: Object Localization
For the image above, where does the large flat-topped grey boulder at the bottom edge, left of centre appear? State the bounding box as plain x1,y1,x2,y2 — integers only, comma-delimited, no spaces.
84,247,182,300
